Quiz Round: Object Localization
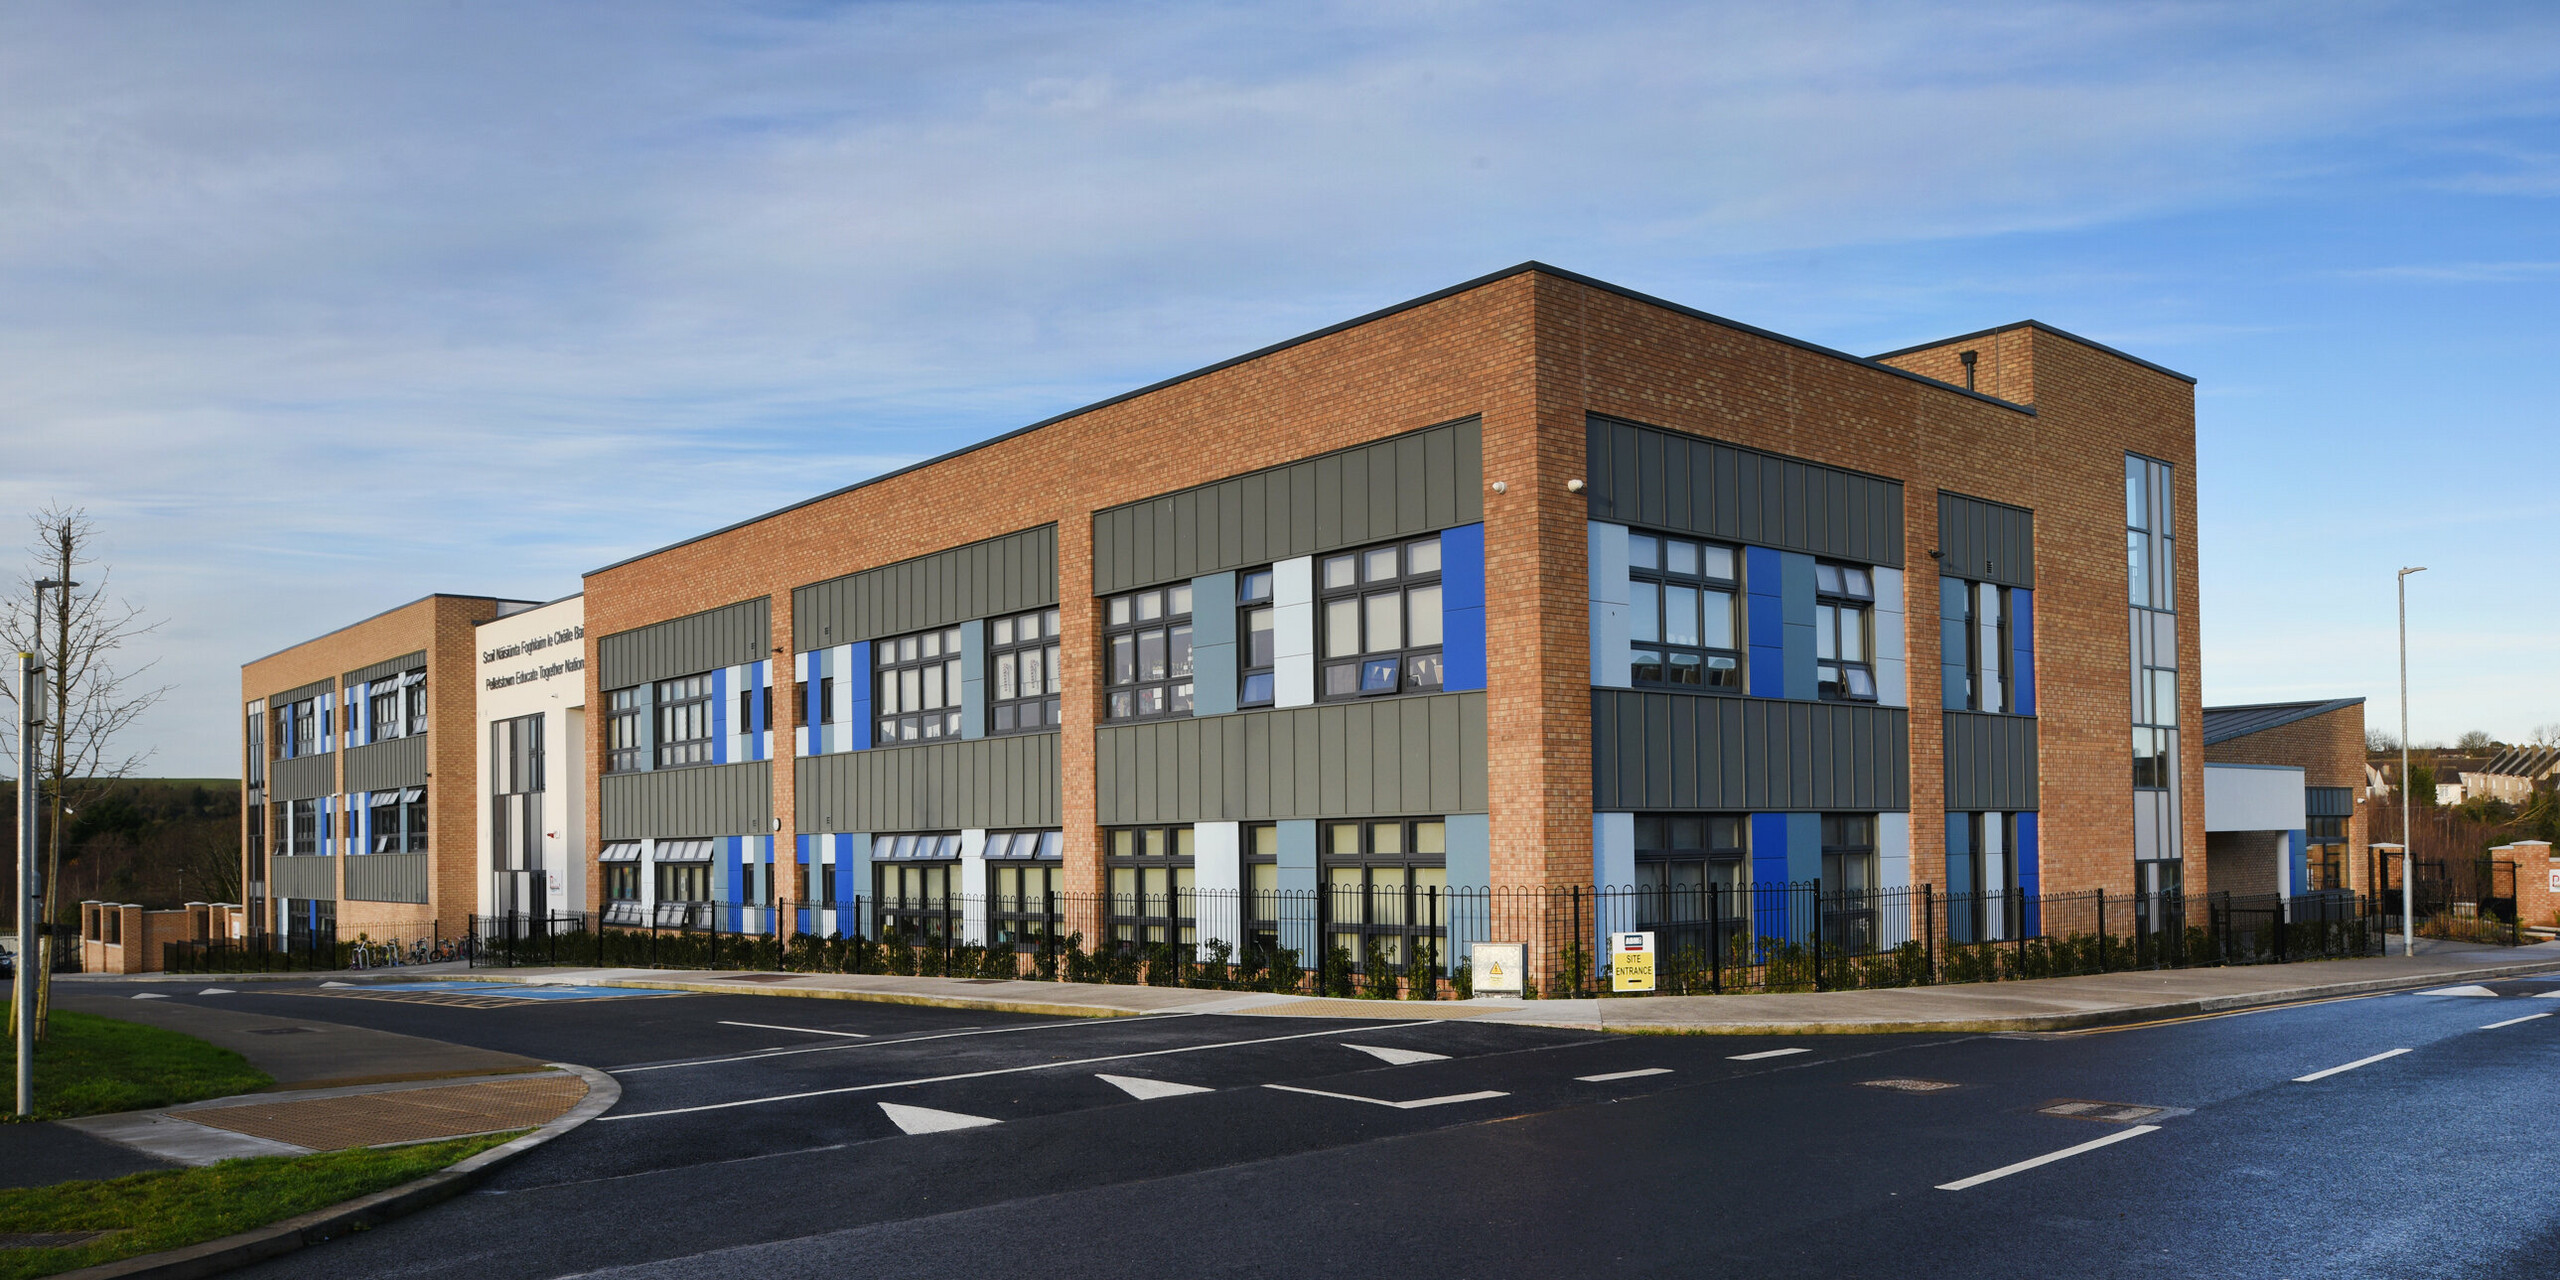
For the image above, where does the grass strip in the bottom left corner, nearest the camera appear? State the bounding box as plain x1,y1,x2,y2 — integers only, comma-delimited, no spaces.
0,1129,525,1280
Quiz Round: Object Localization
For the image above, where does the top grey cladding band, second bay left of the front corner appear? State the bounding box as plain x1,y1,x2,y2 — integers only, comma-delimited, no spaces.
791,525,1057,653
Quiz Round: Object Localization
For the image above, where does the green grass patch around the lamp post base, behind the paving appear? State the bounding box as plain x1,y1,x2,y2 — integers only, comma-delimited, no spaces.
0,1006,276,1119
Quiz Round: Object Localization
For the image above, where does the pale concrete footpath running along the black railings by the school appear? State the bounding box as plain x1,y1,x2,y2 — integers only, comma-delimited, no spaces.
453,940,2560,1034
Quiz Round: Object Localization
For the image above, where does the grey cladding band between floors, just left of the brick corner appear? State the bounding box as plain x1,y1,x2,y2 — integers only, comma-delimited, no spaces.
1096,694,1487,824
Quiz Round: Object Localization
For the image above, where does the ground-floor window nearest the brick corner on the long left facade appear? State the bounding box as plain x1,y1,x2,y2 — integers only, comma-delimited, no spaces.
1318,817,1449,968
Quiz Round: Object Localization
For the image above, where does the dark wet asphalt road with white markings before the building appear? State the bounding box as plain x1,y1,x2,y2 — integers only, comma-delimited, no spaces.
104,980,2560,1280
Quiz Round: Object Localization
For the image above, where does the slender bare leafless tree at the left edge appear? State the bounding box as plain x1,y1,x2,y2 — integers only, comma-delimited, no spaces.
0,502,169,1034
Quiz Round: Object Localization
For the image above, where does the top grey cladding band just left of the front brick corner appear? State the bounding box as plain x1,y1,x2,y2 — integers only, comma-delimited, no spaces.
1093,417,1485,594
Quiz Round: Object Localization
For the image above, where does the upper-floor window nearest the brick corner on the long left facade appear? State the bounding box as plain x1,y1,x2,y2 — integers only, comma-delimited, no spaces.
1316,538,1441,699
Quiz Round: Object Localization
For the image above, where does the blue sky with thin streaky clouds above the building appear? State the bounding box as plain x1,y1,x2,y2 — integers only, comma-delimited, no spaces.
0,3,2560,776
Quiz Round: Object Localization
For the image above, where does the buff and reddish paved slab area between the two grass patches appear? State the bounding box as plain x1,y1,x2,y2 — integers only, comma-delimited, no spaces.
174,1073,586,1152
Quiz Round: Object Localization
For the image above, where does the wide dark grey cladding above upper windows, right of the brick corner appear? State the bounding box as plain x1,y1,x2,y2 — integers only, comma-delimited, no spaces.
1585,415,1902,568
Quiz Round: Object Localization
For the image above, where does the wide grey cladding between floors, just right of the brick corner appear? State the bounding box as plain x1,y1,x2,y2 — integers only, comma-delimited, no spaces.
1592,689,1910,812
